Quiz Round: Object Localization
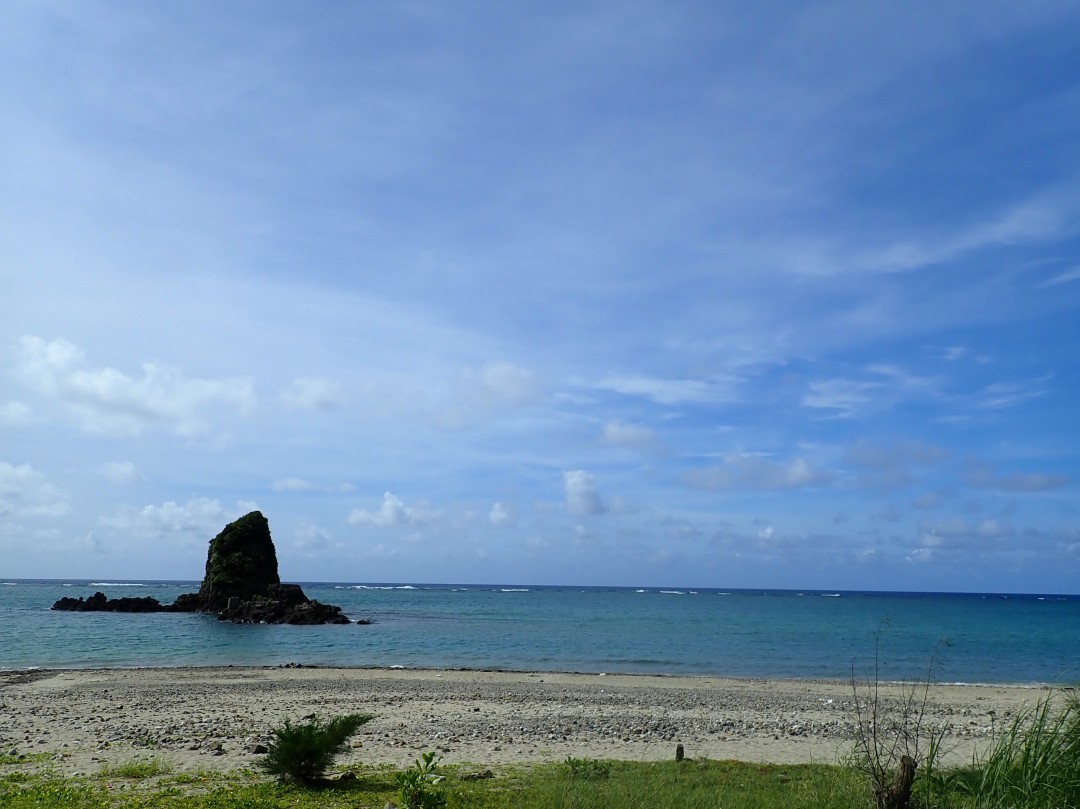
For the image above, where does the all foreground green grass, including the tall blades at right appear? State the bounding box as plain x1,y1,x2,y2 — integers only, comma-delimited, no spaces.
0,693,1080,809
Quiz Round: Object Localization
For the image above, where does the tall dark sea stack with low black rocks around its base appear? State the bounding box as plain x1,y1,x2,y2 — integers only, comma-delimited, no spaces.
53,511,350,624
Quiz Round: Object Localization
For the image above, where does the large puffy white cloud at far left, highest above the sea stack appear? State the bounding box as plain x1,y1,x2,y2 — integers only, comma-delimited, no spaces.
17,337,255,435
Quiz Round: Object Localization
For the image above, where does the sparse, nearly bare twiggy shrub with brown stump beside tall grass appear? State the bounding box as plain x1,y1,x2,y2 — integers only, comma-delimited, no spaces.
851,622,948,809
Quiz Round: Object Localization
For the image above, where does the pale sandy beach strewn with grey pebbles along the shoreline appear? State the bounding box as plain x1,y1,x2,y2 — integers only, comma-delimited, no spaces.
0,666,1048,773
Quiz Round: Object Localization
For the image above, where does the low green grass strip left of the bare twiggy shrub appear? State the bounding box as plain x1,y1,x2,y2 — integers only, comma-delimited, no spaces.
0,761,865,809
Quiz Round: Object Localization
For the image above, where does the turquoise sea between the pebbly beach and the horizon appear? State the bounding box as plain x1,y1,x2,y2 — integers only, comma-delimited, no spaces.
0,580,1080,684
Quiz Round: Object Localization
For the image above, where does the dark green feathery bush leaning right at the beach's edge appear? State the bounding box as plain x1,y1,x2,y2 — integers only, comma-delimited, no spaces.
259,714,375,784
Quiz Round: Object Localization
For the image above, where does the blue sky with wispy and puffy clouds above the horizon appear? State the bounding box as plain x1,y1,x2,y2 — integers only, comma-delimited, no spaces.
0,0,1080,593
